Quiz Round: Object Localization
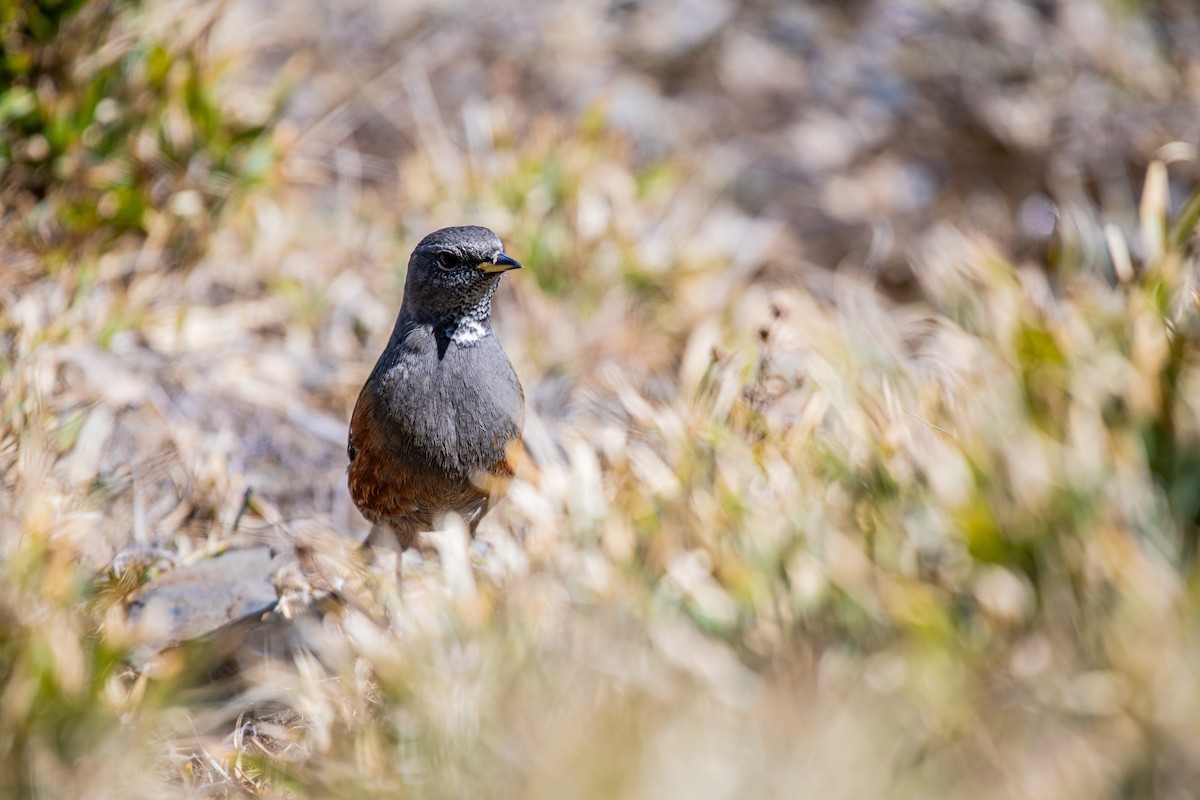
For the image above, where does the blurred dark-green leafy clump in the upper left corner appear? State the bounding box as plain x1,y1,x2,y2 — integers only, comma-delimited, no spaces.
0,0,275,263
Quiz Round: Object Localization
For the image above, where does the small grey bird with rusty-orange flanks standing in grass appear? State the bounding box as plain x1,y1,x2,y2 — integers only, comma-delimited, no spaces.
347,225,524,551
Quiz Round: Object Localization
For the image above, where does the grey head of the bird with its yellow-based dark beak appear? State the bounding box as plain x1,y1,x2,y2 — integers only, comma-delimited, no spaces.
404,225,521,320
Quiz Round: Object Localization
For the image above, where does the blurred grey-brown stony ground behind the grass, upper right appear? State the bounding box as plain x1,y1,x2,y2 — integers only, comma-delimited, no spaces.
260,0,1200,291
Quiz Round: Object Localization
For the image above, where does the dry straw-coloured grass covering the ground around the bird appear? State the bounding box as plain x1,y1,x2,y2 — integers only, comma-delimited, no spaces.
0,4,1200,800
